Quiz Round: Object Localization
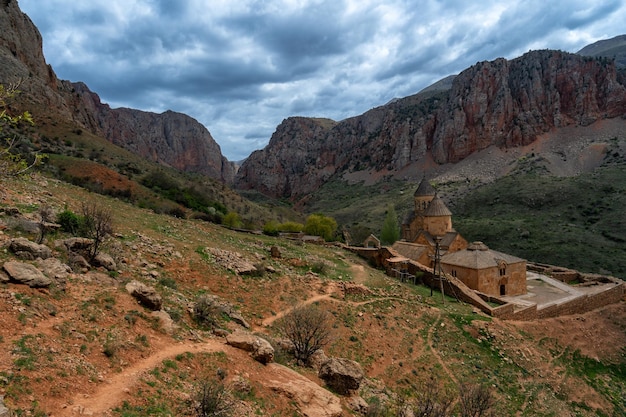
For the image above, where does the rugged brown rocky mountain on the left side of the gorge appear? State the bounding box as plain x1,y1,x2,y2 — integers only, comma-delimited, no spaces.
0,1,236,183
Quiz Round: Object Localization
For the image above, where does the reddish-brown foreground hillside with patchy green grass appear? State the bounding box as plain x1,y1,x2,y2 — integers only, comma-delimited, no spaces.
0,174,626,417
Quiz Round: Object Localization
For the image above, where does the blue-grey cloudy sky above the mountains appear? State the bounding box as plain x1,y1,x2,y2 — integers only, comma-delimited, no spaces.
19,0,626,160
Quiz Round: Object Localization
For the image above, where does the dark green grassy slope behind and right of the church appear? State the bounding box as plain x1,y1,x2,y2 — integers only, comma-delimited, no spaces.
452,165,626,278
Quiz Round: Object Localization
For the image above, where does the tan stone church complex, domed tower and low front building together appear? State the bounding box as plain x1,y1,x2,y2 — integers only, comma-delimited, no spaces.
393,178,526,296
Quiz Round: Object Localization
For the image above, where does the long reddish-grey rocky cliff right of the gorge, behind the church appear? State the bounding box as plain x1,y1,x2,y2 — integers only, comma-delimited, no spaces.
235,50,626,200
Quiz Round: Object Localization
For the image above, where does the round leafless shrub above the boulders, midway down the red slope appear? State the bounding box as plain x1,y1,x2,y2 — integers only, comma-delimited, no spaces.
278,305,331,364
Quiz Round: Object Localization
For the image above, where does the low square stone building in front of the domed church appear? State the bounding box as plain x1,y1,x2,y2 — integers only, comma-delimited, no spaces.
441,242,526,296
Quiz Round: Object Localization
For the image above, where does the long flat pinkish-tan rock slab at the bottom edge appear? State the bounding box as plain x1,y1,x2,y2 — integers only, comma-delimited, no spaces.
264,363,342,417
